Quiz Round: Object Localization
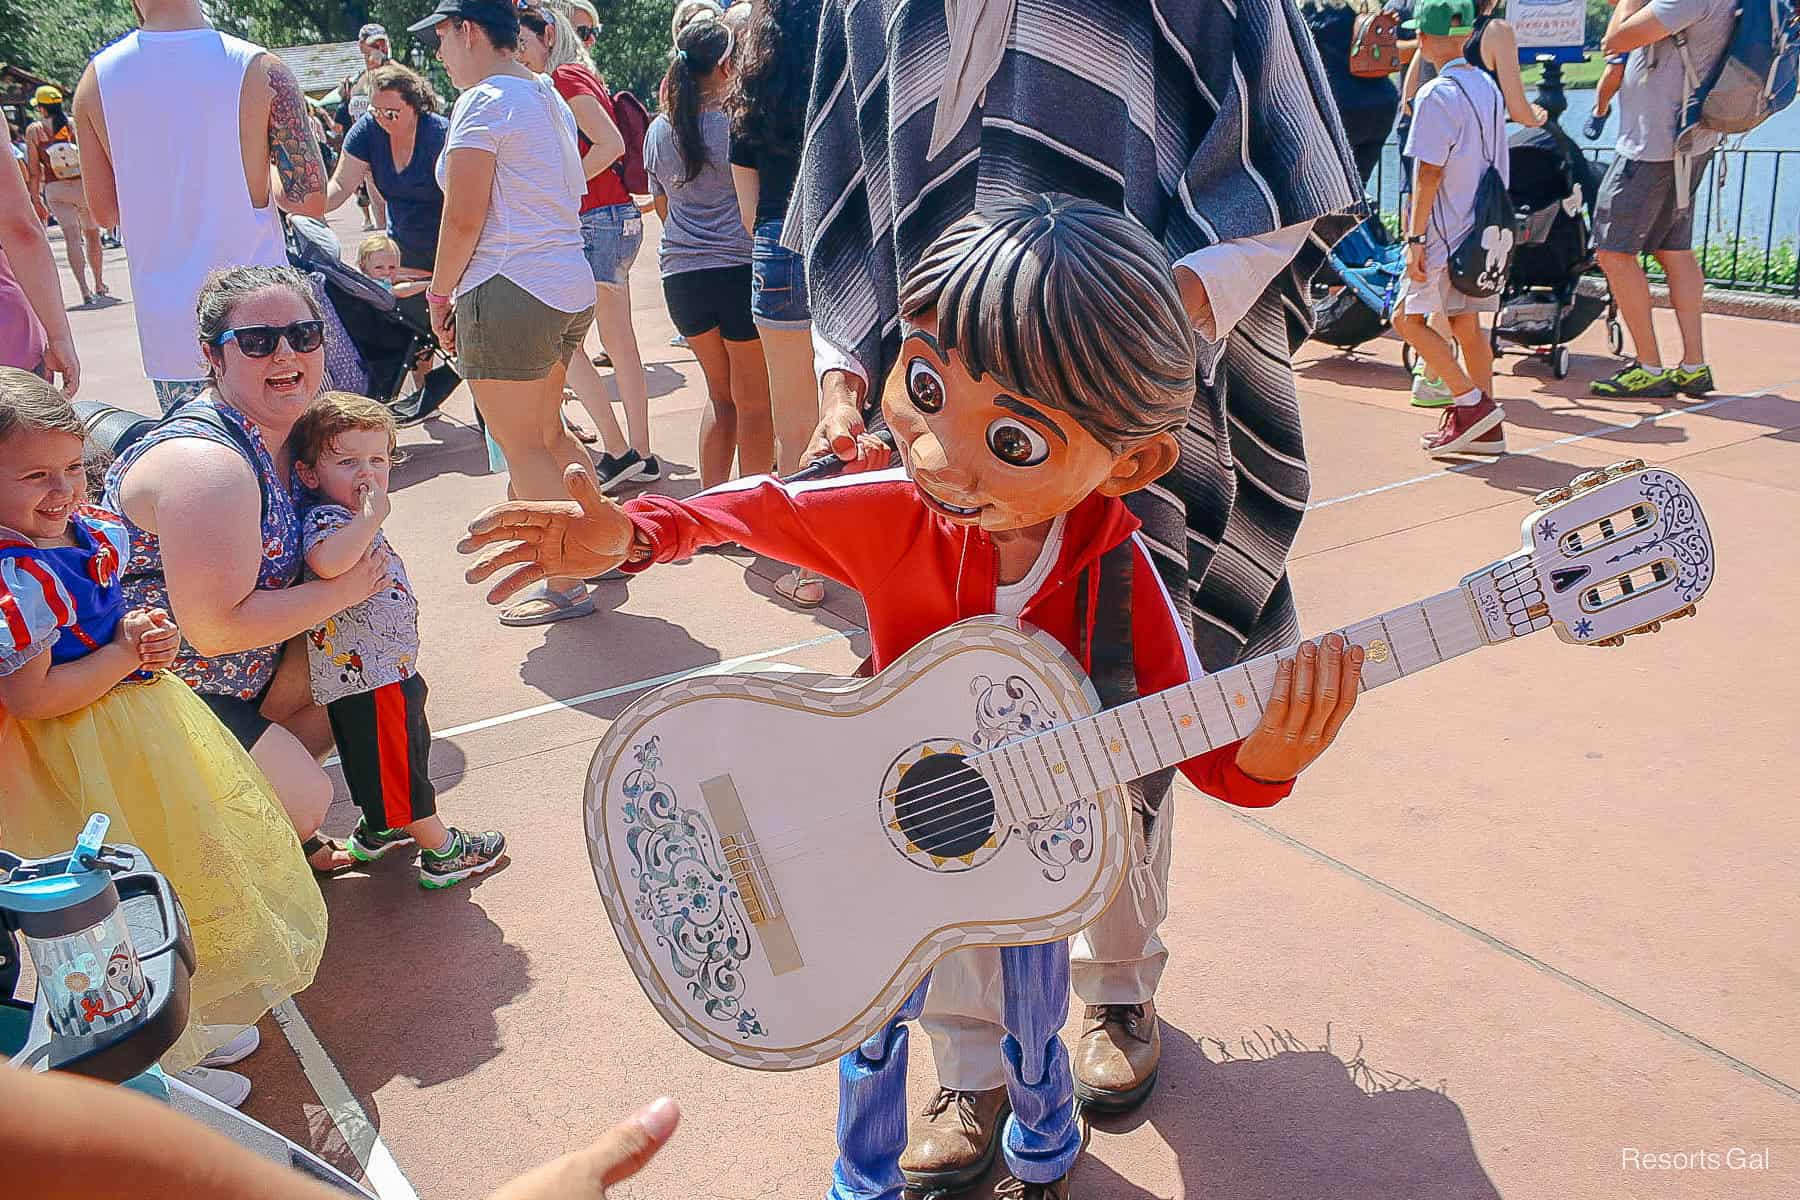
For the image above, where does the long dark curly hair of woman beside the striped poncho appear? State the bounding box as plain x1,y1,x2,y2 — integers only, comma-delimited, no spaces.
725,0,819,157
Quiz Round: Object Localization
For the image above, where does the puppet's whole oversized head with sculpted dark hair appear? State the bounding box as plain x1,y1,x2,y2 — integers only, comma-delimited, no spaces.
882,194,1195,531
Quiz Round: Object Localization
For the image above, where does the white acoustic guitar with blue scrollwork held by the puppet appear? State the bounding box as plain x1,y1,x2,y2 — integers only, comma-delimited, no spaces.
583,461,1712,1070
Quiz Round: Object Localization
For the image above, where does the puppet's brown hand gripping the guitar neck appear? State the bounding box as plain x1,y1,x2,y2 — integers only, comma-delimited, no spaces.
1237,633,1363,783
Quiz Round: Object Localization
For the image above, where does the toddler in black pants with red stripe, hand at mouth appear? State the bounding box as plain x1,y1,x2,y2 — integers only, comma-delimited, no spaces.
288,392,506,889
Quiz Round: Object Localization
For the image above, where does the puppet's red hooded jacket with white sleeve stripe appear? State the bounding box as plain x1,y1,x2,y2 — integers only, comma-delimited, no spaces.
625,468,1294,808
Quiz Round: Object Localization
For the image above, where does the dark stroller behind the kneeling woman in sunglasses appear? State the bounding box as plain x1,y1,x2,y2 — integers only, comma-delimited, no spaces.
288,219,463,425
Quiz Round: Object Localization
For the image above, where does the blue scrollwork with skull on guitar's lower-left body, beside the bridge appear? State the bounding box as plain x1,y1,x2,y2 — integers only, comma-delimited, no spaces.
619,738,765,1036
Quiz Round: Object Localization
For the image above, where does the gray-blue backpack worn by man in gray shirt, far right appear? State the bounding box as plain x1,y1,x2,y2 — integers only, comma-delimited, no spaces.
1672,0,1800,140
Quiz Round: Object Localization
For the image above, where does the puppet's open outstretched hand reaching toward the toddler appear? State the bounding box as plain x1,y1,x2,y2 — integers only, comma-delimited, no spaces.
455,466,634,604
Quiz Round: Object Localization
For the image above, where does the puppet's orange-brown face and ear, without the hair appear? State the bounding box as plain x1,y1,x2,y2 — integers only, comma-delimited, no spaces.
882,313,1174,533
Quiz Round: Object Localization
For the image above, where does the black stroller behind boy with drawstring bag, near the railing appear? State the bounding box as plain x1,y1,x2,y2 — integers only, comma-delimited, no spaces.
1492,124,1625,380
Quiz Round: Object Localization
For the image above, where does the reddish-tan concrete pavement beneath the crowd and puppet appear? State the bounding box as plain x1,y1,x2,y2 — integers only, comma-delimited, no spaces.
45,209,1800,1200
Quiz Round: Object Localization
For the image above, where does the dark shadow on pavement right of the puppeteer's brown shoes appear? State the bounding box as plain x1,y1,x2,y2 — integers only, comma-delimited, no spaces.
1075,1022,1499,1200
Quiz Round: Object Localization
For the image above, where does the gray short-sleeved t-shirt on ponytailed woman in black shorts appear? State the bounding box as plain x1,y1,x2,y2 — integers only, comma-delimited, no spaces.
644,112,751,275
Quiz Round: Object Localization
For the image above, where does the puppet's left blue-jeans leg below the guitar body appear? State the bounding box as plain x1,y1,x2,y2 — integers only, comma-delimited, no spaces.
826,975,931,1200
